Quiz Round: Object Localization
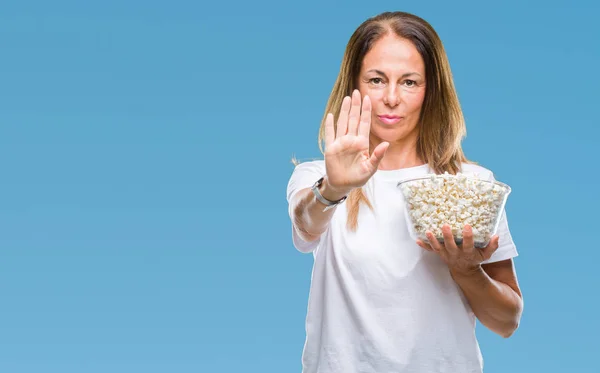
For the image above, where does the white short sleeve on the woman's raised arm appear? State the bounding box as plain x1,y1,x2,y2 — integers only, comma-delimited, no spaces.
287,161,325,253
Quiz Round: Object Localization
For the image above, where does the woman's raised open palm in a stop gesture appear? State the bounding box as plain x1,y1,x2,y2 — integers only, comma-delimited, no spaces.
325,90,389,194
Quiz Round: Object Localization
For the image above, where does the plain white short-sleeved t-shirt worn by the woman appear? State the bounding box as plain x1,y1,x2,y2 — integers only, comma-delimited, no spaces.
287,161,517,373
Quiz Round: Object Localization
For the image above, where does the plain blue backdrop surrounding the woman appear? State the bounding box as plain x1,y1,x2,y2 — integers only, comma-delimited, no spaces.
0,0,600,373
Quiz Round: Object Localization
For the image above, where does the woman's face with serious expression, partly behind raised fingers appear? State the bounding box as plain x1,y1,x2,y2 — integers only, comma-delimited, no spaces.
358,33,425,145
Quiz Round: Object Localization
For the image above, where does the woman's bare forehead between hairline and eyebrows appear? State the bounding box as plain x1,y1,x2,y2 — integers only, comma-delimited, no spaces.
362,34,425,74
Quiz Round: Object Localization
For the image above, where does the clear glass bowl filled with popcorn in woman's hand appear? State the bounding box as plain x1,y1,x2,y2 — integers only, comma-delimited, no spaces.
398,172,511,248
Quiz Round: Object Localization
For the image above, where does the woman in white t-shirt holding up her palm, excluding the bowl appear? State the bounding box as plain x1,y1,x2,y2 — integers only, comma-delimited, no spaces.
287,12,523,373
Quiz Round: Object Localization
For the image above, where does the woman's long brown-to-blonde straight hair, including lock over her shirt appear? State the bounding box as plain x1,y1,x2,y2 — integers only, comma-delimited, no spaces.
318,12,475,230
